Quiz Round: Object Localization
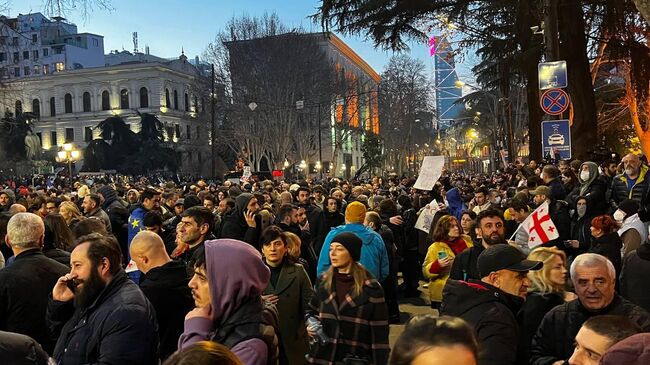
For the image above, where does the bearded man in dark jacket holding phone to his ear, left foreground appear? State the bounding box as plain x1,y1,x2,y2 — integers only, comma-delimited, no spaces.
47,233,158,365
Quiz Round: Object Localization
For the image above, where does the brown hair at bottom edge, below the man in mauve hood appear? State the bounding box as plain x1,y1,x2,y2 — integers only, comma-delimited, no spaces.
163,341,243,365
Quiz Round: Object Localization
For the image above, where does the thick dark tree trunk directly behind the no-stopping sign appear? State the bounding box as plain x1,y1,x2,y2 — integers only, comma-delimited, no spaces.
559,0,598,160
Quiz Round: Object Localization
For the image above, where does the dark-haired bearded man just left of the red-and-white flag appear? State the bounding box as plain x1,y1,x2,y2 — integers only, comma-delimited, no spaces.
449,209,506,280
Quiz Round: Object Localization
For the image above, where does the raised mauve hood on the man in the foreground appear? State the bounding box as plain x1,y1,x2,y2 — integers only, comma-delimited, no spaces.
205,239,271,323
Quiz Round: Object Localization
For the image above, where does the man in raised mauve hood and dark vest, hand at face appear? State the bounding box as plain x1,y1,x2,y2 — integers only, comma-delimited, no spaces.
178,239,279,365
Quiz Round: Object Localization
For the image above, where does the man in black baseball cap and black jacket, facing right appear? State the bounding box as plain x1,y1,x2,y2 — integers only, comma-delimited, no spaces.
440,245,543,365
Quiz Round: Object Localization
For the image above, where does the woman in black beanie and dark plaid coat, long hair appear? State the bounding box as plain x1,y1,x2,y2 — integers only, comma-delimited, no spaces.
307,232,390,364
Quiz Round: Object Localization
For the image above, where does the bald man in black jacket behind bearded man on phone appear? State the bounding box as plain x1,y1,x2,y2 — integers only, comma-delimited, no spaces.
131,231,194,360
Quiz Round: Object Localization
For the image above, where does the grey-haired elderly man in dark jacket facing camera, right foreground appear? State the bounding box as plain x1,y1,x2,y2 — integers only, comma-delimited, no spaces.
530,253,650,365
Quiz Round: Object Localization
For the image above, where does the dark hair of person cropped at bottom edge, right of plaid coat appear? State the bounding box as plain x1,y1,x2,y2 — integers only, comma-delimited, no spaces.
389,314,478,365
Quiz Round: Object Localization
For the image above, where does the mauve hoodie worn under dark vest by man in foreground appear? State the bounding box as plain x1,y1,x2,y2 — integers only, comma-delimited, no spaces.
178,239,277,365
